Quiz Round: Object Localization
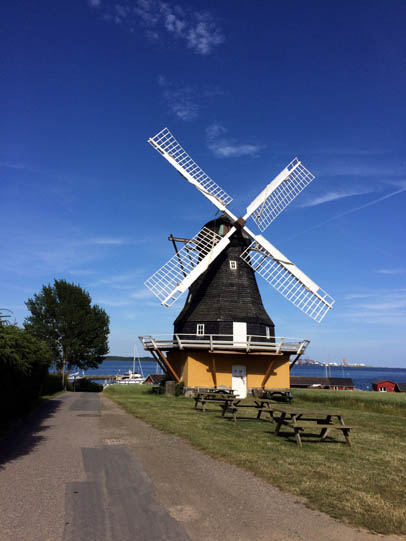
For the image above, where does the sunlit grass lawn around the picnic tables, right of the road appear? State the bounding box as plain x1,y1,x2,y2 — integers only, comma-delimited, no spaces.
104,385,406,535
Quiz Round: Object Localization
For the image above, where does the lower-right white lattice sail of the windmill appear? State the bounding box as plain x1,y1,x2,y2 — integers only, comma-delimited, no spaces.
241,235,334,323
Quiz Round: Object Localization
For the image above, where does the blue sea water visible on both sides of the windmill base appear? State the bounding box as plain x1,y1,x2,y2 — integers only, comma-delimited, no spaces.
86,360,406,391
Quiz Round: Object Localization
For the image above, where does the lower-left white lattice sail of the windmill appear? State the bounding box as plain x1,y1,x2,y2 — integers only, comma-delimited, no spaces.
145,227,225,306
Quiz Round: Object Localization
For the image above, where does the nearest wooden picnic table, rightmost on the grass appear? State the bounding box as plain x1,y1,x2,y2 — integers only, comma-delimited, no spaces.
270,405,352,447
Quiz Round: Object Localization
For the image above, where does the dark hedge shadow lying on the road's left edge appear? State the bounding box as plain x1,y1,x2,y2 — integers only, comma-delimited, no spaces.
0,397,63,471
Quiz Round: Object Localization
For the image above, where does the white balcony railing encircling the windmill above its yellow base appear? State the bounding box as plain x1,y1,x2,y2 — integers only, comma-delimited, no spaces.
139,334,309,355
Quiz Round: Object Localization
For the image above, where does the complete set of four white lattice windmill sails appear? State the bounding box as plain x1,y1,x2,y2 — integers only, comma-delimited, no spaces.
145,128,335,323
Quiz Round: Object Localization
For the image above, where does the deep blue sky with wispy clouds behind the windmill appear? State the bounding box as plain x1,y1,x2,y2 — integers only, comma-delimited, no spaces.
0,0,406,367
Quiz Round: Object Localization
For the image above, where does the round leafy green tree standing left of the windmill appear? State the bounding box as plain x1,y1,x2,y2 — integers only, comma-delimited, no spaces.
24,280,110,384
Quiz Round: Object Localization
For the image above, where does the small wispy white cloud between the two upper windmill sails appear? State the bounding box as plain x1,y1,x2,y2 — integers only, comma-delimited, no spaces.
206,123,265,158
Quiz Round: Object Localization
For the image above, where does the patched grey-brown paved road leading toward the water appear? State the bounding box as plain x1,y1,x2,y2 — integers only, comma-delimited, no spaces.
0,393,399,541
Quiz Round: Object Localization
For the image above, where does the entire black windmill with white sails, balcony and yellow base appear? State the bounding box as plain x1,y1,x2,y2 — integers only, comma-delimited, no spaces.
140,128,334,397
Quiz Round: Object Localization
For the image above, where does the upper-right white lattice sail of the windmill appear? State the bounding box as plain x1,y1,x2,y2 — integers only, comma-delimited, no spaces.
245,158,315,231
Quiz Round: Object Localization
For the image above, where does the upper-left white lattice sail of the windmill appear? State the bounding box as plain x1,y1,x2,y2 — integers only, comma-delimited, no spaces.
148,128,233,210
